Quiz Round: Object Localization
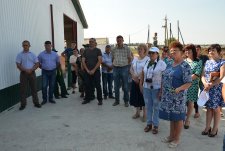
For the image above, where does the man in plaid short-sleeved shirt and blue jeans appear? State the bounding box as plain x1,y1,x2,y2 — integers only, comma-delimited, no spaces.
112,35,131,107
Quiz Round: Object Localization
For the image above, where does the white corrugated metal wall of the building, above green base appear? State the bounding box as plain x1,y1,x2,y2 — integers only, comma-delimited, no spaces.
0,0,84,89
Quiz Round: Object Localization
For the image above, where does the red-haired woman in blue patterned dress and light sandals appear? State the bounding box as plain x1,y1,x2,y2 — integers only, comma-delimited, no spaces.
159,41,192,148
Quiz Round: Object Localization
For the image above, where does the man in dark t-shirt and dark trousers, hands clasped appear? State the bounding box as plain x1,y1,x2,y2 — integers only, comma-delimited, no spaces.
82,38,102,105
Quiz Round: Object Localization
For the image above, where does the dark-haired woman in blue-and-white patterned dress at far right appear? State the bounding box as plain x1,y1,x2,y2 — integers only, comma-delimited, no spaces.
202,44,225,137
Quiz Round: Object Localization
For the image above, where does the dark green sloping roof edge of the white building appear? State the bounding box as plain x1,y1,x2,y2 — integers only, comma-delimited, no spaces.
72,0,88,29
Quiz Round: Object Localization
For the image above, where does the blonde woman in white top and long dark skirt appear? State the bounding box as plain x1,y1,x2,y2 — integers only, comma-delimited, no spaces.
130,44,149,121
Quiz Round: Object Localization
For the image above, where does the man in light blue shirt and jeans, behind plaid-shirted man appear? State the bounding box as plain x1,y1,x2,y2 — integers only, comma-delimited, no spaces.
102,45,114,99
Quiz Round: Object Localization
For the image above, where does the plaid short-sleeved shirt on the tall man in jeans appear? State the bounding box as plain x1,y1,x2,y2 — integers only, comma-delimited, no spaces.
111,45,131,67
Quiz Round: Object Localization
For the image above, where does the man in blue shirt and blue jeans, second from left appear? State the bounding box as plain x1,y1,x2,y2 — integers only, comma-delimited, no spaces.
38,41,59,105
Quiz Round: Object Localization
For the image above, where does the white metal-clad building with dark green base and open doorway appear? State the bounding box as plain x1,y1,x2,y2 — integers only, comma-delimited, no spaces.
0,0,88,112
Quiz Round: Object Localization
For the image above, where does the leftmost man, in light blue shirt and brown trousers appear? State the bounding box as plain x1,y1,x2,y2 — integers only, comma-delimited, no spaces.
16,40,41,110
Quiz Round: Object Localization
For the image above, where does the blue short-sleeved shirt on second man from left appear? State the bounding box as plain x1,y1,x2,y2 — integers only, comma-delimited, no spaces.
38,50,60,70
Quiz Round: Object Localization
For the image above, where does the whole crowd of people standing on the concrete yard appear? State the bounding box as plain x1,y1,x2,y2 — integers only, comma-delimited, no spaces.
16,35,225,148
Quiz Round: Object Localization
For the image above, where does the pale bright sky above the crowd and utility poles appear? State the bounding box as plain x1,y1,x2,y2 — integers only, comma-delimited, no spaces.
80,0,225,44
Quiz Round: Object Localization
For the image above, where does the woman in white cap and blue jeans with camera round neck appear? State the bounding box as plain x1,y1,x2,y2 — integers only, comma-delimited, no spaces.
140,47,166,134
